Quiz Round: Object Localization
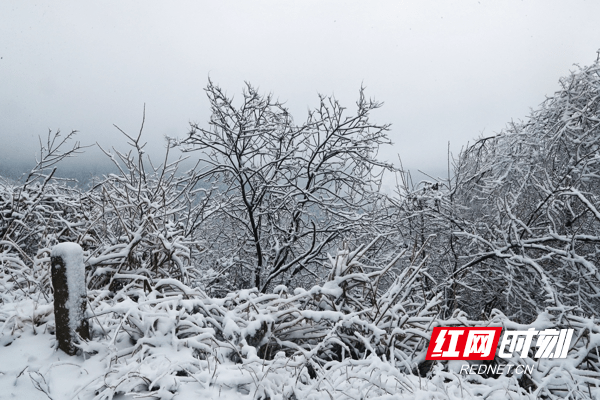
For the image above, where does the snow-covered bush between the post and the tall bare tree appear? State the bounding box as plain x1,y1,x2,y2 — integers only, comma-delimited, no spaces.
79,120,216,291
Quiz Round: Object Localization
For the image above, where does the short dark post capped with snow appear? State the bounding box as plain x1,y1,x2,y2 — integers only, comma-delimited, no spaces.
51,243,90,355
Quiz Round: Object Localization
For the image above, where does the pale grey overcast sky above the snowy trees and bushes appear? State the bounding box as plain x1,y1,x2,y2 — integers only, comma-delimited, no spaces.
0,0,600,183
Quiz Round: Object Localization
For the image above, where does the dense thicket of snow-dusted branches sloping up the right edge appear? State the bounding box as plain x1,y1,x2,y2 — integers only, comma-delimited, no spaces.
399,59,600,322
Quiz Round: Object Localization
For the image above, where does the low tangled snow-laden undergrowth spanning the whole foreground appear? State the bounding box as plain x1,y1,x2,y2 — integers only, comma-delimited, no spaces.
0,244,600,400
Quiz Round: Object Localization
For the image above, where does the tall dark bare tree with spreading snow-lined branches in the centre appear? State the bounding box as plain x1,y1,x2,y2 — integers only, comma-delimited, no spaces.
182,82,393,292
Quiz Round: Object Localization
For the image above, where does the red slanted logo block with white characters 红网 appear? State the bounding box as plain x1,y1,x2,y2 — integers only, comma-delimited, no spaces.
426,326,502,360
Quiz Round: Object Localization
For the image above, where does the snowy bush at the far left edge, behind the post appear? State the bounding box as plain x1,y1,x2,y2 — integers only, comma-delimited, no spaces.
0,131,89,302
